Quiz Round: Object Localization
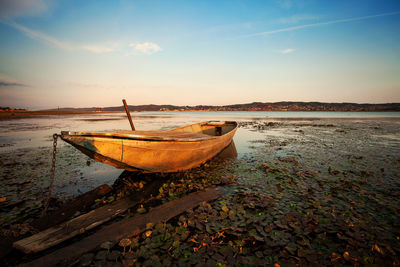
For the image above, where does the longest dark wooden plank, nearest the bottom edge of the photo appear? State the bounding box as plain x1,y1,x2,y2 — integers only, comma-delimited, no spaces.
20,188,221,266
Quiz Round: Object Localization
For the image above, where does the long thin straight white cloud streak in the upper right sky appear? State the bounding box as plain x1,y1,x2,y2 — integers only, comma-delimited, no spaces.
238,11,400,39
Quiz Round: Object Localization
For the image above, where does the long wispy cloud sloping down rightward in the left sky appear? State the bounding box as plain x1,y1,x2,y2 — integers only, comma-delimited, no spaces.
6,21,115,54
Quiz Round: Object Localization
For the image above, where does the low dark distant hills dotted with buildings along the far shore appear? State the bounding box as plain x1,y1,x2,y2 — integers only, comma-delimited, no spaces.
46,101,400,112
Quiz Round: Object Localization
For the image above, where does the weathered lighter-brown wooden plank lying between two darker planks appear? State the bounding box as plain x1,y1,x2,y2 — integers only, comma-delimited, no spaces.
13,195,138,253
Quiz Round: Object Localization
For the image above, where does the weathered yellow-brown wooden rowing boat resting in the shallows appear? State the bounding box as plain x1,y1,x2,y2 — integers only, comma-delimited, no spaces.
61,121,237,172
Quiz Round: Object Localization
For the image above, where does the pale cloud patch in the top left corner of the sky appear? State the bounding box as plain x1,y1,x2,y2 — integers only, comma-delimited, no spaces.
0,0,50,19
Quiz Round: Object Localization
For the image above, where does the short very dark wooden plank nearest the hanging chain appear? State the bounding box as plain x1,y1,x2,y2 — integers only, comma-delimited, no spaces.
30,184,112,231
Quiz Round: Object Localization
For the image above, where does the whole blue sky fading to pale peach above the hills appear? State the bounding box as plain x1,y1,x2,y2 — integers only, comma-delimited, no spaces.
0,0,400,109
